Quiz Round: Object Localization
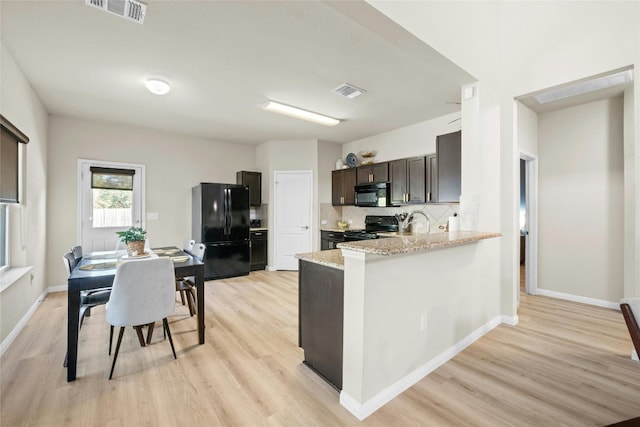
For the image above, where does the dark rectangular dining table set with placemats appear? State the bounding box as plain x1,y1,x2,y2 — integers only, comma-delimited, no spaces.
67,246,204,381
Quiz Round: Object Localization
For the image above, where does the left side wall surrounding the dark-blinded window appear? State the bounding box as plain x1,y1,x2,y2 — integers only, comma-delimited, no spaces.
0,45,49,344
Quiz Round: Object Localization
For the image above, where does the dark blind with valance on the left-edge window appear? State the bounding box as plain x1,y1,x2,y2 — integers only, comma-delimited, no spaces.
0,114,29,203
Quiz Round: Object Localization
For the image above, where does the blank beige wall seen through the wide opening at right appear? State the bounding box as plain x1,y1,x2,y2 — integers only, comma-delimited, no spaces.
538,97,624,304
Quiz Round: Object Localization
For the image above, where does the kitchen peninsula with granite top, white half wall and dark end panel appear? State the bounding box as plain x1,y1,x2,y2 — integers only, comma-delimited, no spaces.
297,231,501,419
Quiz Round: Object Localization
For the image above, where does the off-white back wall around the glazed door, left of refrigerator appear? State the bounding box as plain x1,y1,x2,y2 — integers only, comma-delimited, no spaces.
47,116,256,285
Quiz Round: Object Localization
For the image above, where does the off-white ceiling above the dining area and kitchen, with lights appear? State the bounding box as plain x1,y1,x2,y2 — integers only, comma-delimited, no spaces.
0,0,475,144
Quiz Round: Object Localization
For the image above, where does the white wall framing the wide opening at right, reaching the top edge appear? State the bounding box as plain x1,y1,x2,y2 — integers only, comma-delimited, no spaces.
368,1,640,314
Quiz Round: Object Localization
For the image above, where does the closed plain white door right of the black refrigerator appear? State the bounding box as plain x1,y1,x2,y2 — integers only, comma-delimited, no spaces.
274,171,313,270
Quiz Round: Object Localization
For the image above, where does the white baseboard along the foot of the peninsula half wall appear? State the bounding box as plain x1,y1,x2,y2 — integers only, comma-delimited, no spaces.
340,316,503,421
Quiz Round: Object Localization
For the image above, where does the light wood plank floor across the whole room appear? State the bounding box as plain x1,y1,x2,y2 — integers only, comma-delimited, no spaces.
0,272,640,427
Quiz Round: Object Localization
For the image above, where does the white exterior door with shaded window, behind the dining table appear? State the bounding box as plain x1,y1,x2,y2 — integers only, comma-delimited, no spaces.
78,159,145,252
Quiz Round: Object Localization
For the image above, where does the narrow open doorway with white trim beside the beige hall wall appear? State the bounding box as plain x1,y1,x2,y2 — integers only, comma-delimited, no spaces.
518,152,538,295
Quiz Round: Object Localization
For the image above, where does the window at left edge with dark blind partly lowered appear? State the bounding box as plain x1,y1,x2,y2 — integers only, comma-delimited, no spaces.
0,114,29,271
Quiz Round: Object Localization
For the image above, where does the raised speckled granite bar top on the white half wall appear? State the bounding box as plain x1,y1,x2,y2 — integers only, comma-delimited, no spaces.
337,231,501,256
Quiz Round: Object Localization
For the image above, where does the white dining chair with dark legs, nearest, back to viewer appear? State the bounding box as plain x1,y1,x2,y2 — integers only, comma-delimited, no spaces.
107,257,177,379
